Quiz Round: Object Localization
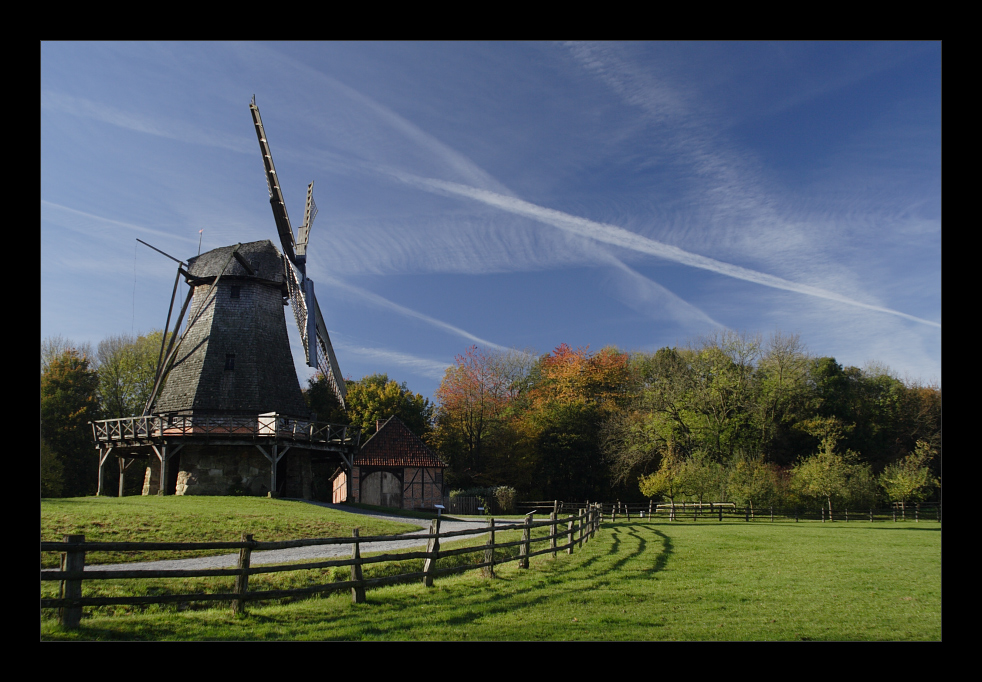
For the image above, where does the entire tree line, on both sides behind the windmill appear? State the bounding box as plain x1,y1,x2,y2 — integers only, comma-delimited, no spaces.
41,331,941,508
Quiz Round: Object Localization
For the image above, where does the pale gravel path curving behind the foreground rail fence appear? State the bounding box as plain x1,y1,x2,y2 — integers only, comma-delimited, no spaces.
51,500,512,570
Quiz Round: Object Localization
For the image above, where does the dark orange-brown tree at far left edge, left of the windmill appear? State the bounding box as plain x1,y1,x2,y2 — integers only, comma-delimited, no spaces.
41,349,99,497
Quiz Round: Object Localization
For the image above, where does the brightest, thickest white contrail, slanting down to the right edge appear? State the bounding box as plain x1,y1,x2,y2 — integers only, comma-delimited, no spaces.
398,173,941,328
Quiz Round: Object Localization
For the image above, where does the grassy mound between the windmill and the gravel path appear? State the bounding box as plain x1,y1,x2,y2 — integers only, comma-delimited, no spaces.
41,495,428,568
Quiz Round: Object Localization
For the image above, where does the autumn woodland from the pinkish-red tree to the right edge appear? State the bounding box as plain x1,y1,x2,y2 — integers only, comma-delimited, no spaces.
418,332,941,506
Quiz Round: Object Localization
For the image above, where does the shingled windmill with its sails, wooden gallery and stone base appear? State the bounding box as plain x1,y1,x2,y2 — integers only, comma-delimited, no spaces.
93,98,359,498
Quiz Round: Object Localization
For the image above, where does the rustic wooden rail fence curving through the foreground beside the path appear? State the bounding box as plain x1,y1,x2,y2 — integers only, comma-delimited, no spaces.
41,505,603,629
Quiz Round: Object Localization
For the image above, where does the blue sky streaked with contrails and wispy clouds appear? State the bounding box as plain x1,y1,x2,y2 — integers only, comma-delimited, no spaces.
41,42,941,397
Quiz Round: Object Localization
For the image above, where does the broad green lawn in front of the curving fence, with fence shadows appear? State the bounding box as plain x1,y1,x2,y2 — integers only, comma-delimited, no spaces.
41,520,941,641
